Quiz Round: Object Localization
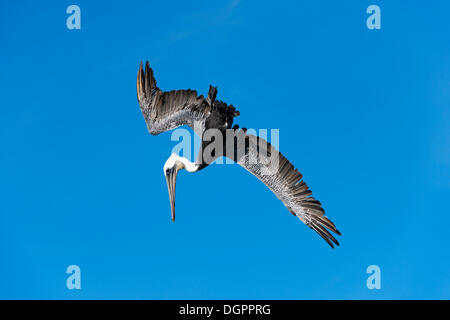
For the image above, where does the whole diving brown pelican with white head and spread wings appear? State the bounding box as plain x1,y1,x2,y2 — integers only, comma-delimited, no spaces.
136,61,341,248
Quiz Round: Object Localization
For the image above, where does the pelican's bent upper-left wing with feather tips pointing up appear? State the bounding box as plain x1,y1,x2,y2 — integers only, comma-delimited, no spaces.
136,61,211,135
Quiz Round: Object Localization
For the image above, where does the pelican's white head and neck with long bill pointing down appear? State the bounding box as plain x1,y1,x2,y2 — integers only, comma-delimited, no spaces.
163,153,199,221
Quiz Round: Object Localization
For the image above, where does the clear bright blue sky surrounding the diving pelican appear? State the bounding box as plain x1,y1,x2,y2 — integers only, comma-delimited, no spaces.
0,0,450,299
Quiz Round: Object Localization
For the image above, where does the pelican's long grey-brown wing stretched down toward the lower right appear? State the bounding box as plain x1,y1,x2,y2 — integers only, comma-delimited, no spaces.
226,129,340,248
